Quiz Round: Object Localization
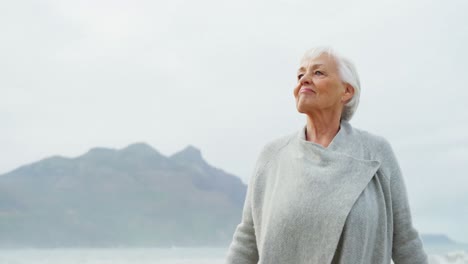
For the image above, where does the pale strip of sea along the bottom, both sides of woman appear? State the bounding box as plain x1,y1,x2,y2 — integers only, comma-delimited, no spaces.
0,248,468,264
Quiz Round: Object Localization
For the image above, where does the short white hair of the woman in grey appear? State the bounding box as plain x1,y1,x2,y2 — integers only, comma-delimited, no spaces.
301,46,361,121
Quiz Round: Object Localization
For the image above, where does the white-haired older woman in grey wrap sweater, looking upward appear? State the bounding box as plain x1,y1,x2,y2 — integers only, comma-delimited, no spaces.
227,47,427,264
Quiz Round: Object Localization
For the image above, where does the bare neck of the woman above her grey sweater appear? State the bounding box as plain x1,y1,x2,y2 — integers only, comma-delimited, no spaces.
306,115,340,147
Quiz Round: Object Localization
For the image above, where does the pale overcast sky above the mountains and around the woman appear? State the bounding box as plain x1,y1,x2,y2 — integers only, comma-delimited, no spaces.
0,0,468,242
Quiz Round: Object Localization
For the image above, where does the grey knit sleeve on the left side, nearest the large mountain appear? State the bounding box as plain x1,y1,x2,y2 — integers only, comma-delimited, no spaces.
226,171,258,264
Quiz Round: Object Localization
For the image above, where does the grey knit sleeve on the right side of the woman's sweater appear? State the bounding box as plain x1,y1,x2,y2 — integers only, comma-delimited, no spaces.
384,140,428,264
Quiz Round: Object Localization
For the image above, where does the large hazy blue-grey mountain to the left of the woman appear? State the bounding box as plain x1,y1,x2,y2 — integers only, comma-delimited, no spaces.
0,143,246,247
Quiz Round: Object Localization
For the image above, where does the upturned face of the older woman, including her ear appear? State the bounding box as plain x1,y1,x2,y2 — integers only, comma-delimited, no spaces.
294,54,352,114
